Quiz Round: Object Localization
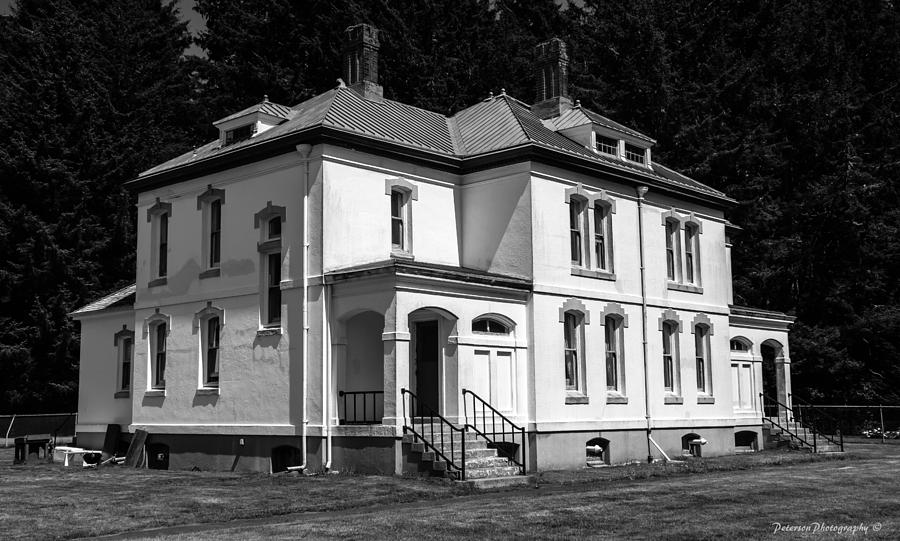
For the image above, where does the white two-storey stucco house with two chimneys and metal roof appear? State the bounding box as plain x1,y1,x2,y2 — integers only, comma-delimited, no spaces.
73,25,792,473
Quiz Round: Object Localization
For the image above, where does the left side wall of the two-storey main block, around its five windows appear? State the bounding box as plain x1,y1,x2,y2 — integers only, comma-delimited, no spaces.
132,151,310,435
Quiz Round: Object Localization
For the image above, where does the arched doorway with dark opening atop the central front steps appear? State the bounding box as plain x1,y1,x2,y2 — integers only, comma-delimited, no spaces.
409,307,458,416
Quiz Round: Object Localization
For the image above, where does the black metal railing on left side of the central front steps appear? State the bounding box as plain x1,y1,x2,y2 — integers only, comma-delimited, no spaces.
400,389,466,481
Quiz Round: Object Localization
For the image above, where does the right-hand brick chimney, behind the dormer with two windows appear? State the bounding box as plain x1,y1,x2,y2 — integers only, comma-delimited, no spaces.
531,38,572,119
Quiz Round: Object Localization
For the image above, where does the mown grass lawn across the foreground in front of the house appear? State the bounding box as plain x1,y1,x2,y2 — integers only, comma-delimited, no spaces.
0,444,900,539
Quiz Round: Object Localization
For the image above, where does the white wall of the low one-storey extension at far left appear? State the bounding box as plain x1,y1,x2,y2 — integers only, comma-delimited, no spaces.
75,309,134,446
